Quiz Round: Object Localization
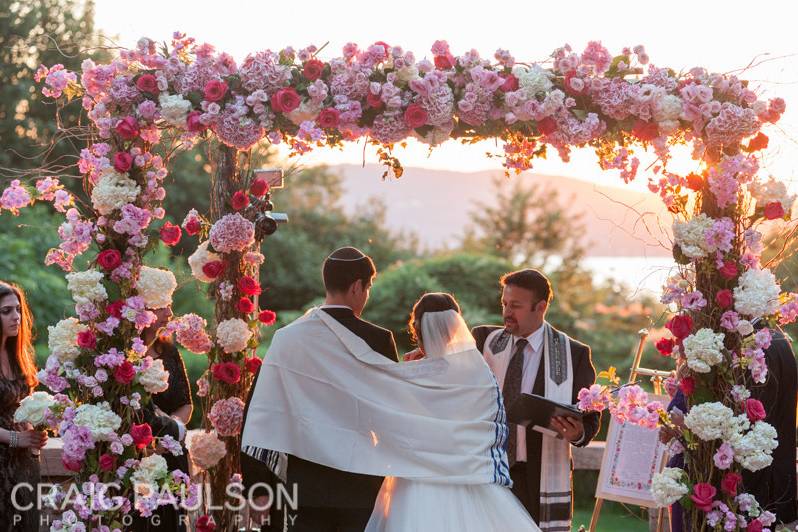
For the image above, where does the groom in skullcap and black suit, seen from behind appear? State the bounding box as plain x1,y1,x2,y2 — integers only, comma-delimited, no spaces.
241,247,398,532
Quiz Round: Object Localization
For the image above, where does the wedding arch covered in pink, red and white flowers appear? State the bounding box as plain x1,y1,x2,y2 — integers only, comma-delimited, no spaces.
2,34,798,530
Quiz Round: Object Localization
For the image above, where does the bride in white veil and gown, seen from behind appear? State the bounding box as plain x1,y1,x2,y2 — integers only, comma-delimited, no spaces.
366,293,539,532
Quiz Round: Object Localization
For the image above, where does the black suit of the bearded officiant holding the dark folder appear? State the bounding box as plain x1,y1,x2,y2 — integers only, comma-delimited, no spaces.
471,325,601,522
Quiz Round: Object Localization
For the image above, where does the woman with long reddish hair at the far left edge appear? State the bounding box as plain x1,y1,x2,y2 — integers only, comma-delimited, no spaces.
0,281,47,532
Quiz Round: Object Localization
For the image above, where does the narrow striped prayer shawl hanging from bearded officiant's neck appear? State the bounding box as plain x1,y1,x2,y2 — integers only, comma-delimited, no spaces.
484,323,574,532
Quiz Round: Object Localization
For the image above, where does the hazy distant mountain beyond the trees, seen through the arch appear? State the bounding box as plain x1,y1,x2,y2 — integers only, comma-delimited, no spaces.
331,165,671,257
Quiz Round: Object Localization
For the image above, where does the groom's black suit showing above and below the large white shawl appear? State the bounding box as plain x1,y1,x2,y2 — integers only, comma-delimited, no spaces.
241,307,399,532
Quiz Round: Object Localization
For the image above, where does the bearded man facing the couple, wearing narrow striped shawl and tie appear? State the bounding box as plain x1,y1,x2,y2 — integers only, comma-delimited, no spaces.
472,269,599,530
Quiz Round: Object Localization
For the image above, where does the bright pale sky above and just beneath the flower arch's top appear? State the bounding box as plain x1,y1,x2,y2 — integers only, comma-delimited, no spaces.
96,0,798,192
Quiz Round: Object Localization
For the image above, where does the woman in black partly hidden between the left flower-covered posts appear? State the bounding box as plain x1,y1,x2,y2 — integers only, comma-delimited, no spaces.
142,307,194,532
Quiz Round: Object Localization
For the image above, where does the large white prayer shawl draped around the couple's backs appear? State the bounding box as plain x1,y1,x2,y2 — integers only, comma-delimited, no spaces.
241,309,511,486
